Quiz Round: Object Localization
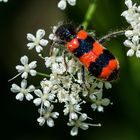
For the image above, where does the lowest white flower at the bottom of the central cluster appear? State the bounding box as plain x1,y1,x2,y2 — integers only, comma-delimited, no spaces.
68,113,89,136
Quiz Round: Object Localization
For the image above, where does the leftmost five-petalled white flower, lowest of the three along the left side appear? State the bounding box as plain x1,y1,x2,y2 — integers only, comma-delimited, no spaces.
11,79,35,101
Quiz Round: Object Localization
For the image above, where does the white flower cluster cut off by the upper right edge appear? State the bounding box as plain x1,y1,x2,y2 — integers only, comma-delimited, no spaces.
122,0,140,57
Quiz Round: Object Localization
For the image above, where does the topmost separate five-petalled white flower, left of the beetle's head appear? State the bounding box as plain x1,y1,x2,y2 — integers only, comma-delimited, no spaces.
27,29,48,53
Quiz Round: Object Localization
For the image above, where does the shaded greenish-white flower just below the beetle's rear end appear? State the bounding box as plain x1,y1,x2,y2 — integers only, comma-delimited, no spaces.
89,90,110,112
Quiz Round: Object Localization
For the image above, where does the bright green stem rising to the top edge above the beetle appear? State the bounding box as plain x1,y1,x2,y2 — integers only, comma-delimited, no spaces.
82,0,96,30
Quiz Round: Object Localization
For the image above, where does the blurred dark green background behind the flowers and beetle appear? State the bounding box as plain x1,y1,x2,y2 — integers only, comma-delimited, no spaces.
0,0,140,140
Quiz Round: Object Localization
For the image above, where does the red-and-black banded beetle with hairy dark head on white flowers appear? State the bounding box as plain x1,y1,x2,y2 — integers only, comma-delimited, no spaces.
55,24,119,81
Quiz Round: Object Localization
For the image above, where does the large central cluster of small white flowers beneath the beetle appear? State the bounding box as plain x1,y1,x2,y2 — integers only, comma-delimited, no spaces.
11,27,112,136
